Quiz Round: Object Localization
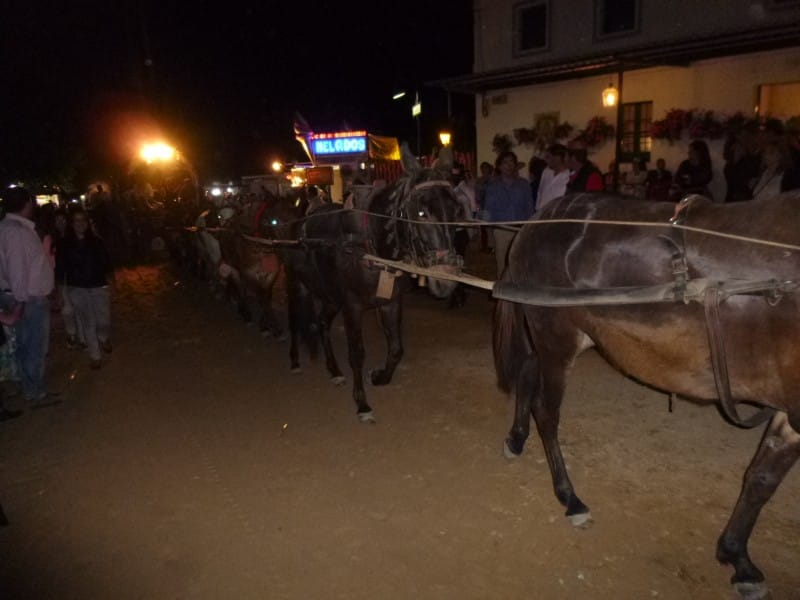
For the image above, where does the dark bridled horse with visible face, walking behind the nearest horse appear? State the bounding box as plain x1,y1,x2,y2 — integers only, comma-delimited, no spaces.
274,147,465,422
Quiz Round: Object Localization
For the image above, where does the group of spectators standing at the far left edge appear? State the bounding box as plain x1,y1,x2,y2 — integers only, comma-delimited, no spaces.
0,187,113,421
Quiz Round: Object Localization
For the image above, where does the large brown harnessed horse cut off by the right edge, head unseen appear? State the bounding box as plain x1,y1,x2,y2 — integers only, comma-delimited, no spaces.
493,192,800,598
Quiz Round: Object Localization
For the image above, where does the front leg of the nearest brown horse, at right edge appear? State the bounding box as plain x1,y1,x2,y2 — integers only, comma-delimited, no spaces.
717,413,800,599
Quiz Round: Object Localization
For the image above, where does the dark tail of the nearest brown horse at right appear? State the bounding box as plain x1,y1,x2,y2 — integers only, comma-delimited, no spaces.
492,300,530,393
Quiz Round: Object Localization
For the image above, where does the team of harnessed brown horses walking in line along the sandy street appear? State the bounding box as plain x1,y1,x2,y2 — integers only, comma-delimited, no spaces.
178,148,800,599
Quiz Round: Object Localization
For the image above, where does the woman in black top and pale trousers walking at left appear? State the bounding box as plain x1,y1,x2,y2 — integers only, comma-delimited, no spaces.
56,210,112,369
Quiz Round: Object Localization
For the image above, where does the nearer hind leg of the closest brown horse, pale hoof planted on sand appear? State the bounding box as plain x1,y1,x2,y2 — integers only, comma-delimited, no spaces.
531,362,592,527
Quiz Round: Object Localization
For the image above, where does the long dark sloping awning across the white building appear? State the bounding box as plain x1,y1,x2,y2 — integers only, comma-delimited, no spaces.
426,23,800,94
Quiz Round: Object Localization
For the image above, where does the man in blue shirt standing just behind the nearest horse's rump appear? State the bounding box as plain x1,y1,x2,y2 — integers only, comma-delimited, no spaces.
483,150,533,279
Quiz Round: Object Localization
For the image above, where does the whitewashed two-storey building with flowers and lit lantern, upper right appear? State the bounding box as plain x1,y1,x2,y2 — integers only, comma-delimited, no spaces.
434,0,800,199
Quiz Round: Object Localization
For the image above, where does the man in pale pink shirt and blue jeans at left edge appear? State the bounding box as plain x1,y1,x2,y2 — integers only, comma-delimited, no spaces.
0,187,54,403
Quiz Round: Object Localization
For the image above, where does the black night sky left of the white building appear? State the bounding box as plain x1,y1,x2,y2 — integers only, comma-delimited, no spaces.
0,0,474,184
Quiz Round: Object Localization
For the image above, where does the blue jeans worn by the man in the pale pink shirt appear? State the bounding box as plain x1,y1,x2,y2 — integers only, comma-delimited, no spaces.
14,296,50,402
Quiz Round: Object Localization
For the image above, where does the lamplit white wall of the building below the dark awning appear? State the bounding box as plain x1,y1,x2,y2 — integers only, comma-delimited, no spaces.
476,48,800,199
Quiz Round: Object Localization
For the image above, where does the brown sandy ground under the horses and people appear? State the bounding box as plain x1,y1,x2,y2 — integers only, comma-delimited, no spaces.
0,252,800,599
